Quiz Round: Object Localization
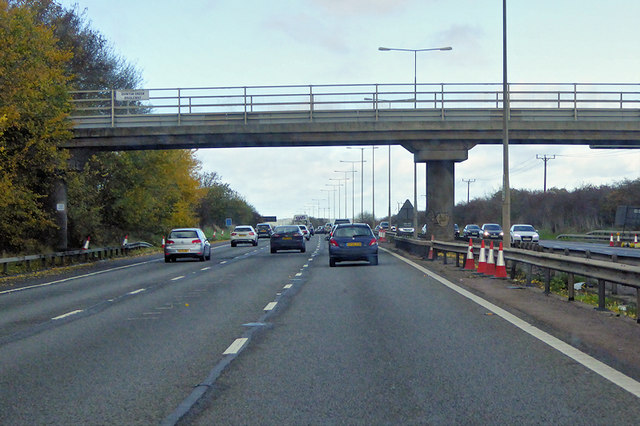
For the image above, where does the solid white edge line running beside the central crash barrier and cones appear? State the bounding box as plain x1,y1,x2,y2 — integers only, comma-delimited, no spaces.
382,249,640,398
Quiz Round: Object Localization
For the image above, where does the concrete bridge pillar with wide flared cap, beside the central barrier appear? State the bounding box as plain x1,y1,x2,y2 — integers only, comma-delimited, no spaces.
412,143,473,241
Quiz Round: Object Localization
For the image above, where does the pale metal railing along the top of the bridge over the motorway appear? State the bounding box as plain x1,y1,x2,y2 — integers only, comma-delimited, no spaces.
72,83,640,127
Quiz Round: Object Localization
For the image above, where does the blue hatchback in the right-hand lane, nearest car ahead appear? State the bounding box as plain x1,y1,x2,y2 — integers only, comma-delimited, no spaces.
329,223,378,266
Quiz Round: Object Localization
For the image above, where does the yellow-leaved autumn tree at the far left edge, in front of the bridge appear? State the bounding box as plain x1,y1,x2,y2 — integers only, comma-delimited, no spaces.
0,0,72,251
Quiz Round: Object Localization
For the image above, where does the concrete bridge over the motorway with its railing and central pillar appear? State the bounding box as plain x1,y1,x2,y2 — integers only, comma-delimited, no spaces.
63,83,640,245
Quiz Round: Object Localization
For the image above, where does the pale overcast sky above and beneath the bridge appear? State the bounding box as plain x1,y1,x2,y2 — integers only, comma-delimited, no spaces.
61,0,640,221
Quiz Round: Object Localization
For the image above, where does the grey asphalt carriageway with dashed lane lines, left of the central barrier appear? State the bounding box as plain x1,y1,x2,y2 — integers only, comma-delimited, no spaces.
0,236,640,425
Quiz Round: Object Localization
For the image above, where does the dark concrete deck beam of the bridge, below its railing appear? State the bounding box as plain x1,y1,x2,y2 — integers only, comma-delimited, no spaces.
63,121,640,153
